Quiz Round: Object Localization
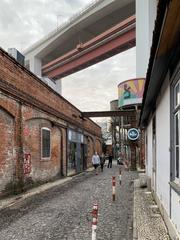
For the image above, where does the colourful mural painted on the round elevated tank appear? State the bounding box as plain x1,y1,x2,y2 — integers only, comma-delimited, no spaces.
118,78,145,107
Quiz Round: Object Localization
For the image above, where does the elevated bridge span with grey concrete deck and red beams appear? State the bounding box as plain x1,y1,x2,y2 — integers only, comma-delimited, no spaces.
24,0,135,80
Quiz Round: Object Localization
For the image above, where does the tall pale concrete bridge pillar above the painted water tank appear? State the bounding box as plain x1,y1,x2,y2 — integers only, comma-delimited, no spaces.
136,0,157,78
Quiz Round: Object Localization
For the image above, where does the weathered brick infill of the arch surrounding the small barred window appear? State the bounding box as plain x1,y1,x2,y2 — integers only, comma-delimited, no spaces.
24,118,62,181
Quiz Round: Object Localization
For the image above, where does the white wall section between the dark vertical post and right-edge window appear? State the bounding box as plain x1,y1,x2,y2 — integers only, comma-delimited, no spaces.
156,83,170,215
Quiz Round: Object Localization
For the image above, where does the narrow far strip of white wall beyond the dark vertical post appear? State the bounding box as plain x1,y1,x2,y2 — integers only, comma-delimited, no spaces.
146,118,152,178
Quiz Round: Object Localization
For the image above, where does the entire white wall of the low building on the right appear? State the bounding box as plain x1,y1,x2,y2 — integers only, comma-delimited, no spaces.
146,75,180,239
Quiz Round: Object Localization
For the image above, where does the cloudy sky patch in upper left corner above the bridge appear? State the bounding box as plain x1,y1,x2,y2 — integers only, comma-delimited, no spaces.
0,0,91,51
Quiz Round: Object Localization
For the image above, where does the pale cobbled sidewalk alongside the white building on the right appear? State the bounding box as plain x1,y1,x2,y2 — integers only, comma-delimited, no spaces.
134,179,170,240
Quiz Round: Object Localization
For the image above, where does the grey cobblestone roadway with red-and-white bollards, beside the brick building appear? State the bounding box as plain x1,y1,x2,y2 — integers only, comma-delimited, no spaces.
0,165,136,240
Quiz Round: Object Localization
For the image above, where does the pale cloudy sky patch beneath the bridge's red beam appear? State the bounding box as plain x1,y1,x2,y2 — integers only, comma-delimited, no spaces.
62,48,136,111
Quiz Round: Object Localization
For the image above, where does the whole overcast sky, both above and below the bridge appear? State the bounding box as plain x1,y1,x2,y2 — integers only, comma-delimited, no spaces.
0,0,136,115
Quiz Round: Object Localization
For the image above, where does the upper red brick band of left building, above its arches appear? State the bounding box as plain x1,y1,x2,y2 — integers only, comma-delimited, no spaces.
0,49,101,136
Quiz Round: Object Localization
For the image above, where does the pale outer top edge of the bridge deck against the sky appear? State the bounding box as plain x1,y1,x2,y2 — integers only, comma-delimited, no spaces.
24,0,105,54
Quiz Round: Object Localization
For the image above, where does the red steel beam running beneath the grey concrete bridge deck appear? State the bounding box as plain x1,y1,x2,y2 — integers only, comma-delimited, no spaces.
42,16,135,79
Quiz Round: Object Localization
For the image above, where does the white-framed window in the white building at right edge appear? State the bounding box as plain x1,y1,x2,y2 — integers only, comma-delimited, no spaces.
173,80,180,183
